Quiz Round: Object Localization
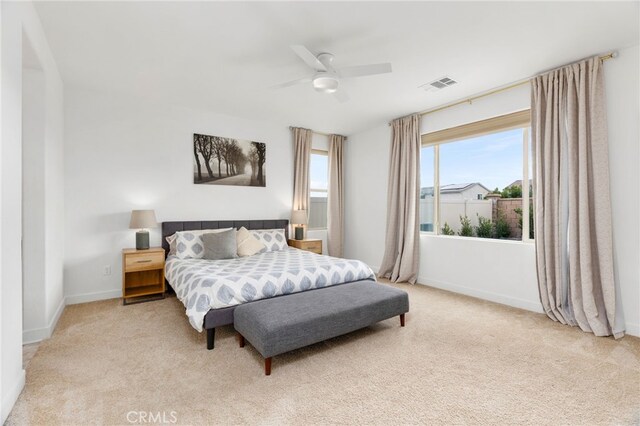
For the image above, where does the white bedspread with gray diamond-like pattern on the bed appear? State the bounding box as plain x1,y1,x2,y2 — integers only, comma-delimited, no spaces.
165,247,375,331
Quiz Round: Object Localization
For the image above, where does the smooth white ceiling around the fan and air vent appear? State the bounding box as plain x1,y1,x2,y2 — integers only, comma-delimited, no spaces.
36,2,640,134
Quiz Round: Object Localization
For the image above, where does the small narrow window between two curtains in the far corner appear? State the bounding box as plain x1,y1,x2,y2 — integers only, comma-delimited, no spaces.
309,149,329,229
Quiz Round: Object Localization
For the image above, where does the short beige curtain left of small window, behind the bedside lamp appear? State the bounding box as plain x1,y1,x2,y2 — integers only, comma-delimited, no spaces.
291,127,313,219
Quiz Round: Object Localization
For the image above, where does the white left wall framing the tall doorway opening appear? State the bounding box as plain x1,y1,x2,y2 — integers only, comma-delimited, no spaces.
0,2,64,421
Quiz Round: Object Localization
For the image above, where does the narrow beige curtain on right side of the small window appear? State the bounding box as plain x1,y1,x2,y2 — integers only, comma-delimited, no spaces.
327,135,346,257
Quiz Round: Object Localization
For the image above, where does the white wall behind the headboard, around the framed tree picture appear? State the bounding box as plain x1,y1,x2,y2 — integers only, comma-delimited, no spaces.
65,87,293,303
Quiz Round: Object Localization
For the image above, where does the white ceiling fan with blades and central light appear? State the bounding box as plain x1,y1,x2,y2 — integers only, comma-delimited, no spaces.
273,45,391,102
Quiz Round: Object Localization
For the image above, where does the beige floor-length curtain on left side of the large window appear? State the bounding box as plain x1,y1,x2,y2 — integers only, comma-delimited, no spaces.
379,114,420,284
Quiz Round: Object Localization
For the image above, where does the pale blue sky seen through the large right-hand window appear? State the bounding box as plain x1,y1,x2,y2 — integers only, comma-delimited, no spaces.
420,129,523,190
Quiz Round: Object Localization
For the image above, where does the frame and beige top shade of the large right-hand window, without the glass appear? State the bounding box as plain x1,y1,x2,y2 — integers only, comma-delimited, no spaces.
420,109,535,243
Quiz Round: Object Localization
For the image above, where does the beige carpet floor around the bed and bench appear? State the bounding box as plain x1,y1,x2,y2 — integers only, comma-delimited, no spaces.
7,286,640,425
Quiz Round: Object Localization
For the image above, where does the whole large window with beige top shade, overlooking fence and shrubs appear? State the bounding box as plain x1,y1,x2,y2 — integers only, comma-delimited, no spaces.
420,111,533,241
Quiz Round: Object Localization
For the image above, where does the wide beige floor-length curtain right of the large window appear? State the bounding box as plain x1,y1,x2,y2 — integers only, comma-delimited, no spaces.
531,57,624,337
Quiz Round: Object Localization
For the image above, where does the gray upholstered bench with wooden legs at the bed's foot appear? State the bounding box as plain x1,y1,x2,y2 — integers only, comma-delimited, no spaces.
233,281,409,376
